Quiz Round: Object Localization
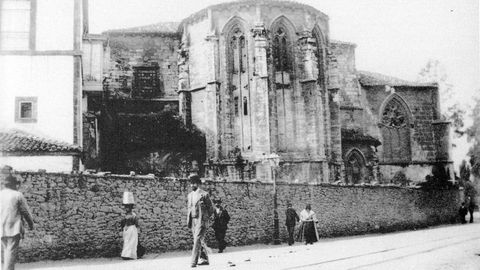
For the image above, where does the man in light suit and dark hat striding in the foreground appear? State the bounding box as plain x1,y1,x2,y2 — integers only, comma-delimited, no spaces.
187,175,214,267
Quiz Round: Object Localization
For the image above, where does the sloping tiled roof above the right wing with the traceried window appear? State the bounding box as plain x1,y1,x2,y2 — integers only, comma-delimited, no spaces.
358,71,437,87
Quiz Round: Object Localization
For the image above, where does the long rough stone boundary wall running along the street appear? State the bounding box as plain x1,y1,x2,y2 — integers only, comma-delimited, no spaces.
13,173,460,261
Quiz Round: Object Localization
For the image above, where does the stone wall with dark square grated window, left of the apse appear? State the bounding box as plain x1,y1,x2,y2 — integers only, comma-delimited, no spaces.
104,23,180,99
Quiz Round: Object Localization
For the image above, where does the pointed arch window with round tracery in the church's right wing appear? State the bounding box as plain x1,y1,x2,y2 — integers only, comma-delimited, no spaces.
380,95,411,163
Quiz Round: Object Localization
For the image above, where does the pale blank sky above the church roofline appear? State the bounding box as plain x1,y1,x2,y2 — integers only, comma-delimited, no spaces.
90,0,480,104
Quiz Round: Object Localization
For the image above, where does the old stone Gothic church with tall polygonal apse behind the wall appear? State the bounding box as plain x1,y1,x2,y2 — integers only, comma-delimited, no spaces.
94,0,453,184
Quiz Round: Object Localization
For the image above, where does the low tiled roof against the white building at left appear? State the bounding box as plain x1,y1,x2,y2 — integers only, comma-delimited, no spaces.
0,130,81,154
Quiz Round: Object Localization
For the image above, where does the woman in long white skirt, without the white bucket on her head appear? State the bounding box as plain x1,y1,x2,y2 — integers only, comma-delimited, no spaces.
120,204,138,260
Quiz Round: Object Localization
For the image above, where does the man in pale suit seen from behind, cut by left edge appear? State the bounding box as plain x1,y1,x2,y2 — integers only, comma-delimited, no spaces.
0,173,33,270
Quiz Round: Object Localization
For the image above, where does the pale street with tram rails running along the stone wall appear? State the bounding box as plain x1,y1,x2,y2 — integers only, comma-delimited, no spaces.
17,213,480,270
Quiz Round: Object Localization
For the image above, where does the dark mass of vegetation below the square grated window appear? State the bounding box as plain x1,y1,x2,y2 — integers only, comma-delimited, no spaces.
102,106,206,177
